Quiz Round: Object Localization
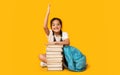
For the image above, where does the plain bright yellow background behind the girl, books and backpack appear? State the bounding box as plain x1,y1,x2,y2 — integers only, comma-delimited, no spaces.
0,0,120,75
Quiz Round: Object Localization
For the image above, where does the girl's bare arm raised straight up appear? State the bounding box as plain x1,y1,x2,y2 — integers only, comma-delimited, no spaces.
43,4,50,35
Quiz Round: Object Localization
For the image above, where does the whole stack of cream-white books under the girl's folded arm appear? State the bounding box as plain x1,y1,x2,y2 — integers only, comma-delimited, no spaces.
46,45,63,70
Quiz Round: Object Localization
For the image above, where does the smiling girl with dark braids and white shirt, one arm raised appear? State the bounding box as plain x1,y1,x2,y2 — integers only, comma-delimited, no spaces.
39,5,70,67
